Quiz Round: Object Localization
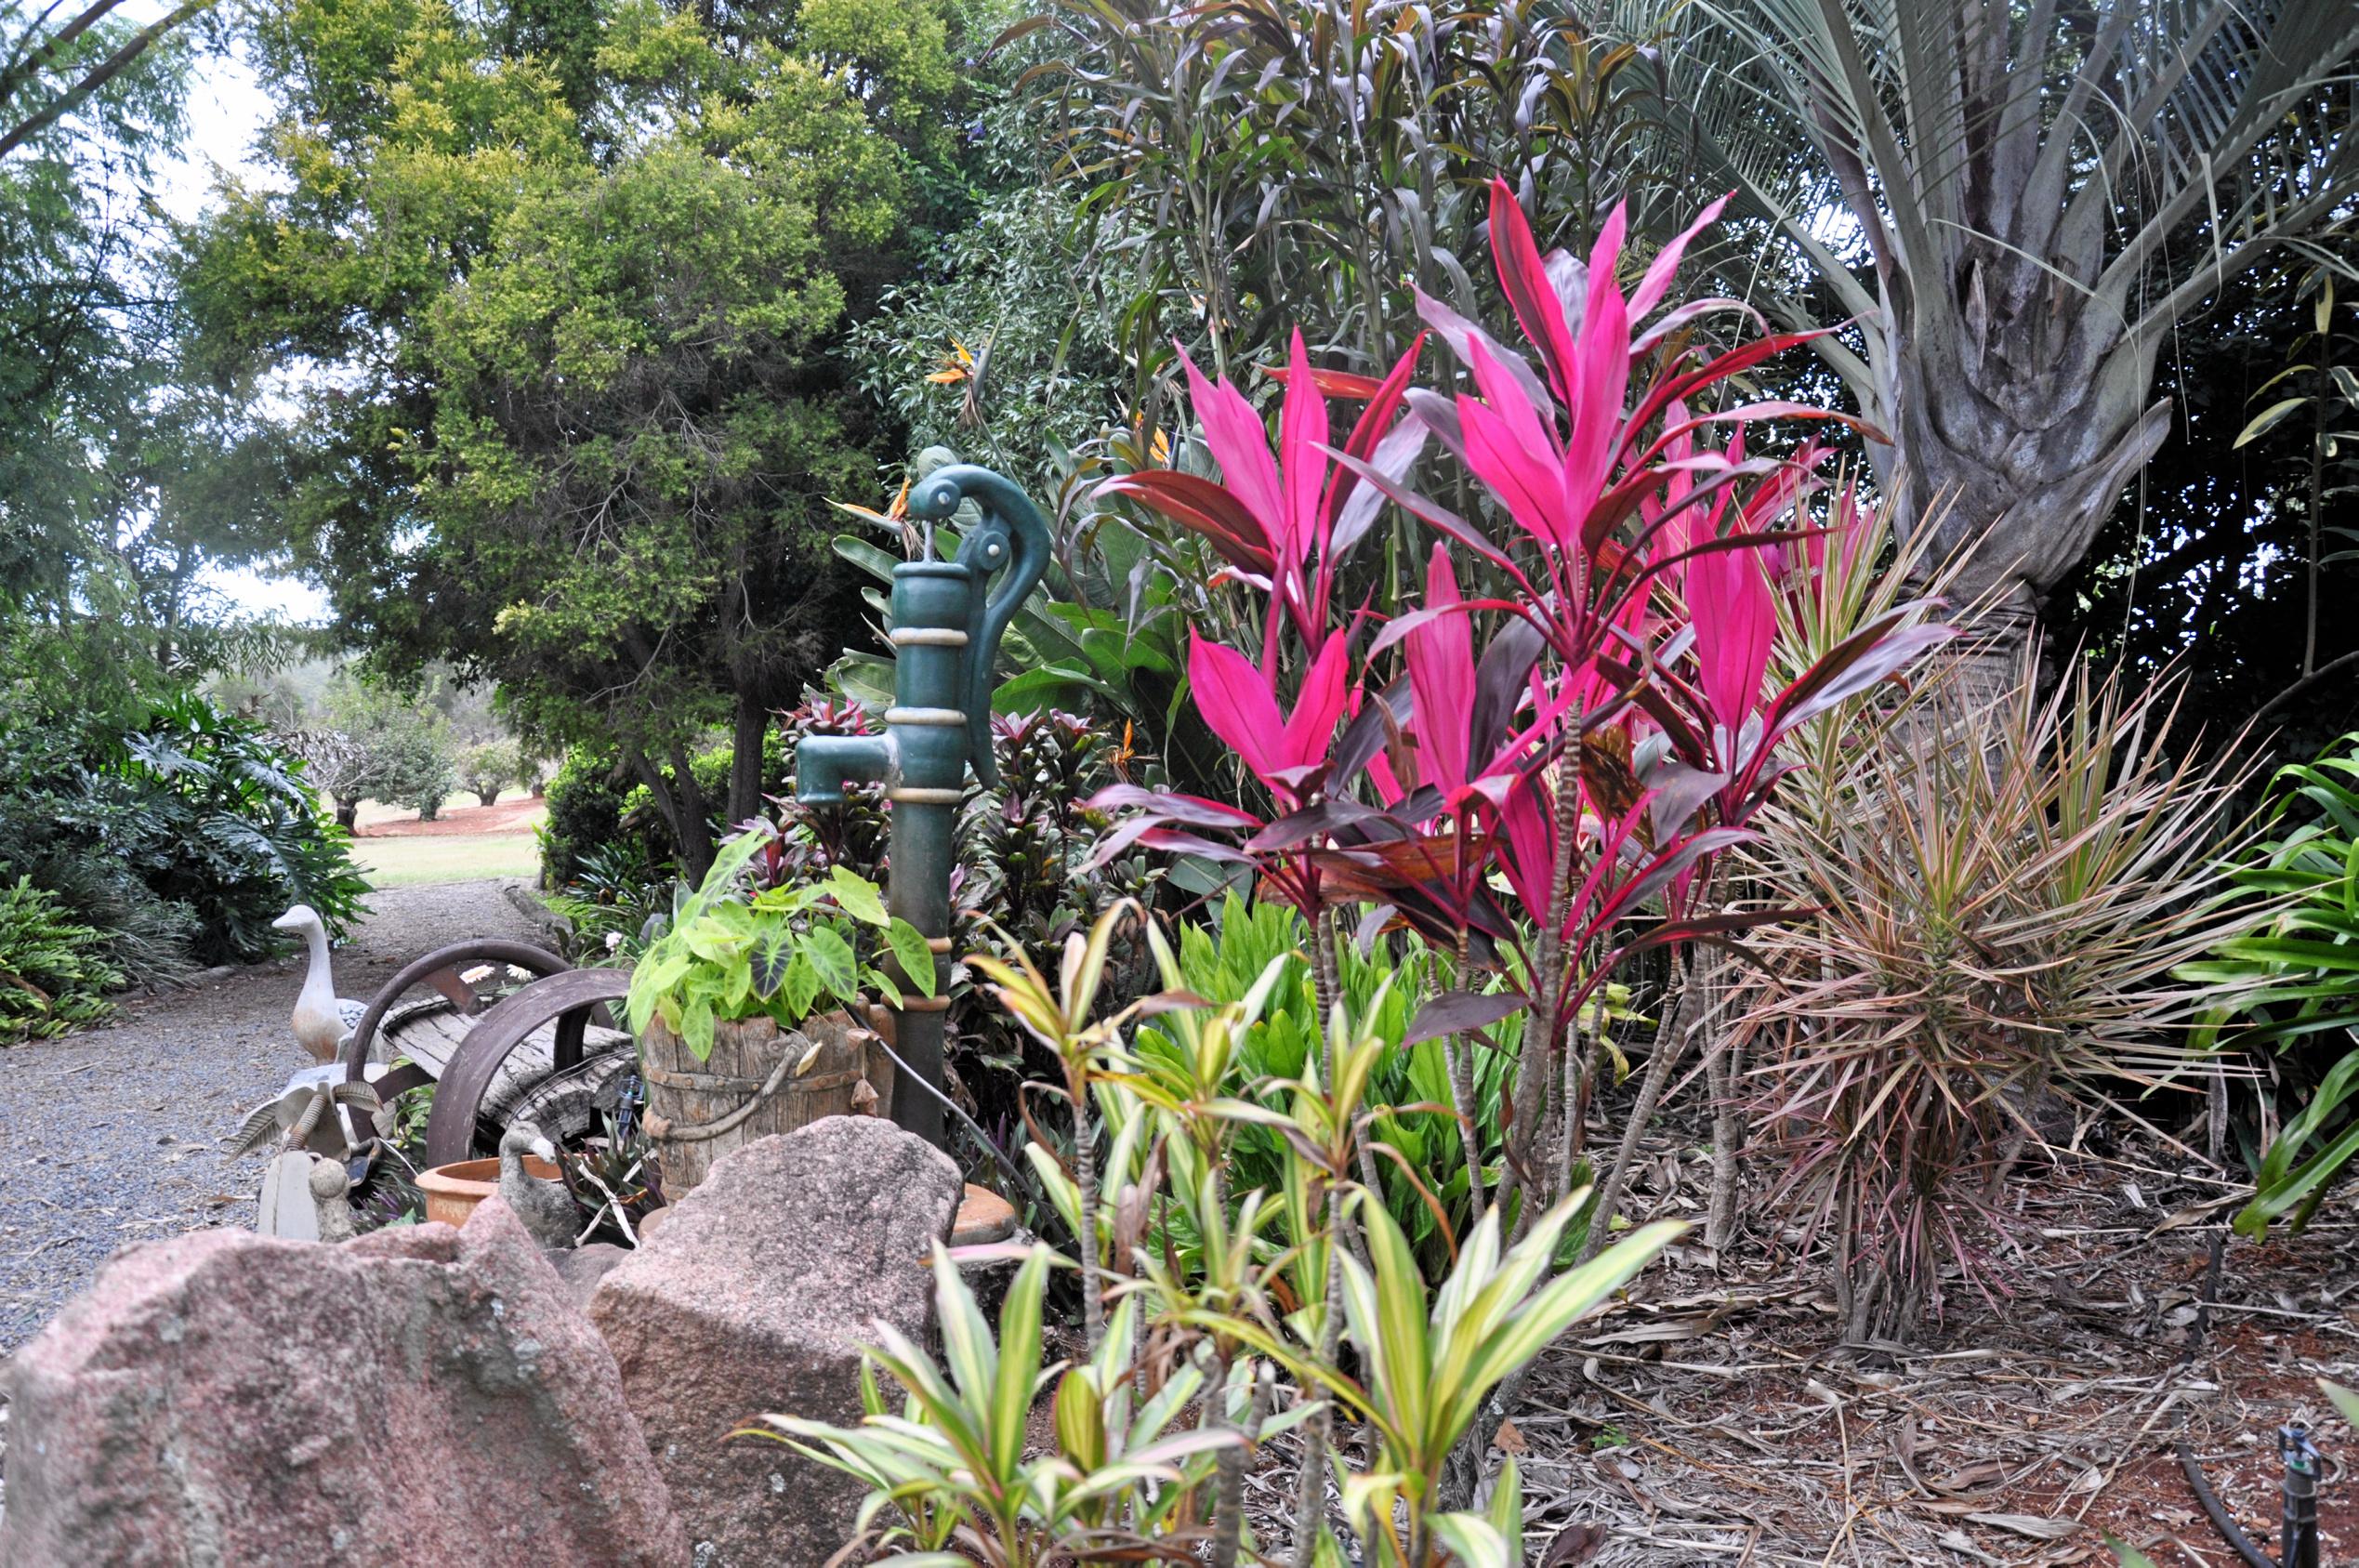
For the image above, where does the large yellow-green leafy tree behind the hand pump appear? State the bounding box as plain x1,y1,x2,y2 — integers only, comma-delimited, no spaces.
181,0,976,875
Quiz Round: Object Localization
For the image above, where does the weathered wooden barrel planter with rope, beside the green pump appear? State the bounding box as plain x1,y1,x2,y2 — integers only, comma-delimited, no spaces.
639,1011,891,1200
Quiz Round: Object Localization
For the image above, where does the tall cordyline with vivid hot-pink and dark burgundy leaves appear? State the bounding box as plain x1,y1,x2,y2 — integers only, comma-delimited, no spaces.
1097,170,1944,1443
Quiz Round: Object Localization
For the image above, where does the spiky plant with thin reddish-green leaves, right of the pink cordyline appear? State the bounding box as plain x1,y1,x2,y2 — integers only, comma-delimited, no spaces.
1736,669,2260,1337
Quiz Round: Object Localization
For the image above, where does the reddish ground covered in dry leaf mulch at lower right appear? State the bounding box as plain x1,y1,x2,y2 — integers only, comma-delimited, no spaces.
1253,1139,2359,1568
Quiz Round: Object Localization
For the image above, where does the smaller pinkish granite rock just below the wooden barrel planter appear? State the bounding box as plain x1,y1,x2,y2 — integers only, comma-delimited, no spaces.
590,1115,960,1568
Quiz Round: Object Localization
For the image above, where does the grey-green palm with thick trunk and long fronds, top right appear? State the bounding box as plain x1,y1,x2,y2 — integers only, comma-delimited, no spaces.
1658,0,2359,651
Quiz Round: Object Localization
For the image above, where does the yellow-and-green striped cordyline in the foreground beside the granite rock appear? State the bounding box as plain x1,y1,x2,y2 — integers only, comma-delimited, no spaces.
755,910,1682,1568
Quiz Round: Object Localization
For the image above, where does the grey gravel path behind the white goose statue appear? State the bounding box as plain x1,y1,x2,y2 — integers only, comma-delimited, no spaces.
0,882,551,1353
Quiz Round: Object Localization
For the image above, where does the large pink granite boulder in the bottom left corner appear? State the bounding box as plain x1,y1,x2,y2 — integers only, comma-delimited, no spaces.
0,1198,689,1568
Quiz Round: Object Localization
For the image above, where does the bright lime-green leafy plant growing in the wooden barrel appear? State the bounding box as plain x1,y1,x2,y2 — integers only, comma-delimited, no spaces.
627,825,934,1061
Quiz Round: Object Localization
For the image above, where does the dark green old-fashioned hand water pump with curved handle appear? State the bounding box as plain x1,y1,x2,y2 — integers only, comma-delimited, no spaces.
795,462,1049,1148
